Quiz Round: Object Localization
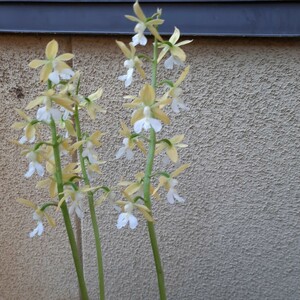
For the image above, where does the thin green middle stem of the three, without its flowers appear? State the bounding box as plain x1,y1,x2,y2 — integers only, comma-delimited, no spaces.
74,105,105,300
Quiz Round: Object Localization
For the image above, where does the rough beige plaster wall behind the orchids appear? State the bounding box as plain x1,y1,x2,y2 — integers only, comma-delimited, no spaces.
0,35,300,300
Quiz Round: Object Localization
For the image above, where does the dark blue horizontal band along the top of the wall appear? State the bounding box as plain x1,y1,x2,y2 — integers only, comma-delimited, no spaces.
0,0,300,37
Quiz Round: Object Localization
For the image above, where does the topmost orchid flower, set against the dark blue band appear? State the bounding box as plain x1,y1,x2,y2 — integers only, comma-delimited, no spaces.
125,1,164,46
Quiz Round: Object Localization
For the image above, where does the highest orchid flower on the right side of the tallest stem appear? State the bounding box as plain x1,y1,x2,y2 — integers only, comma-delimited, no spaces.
158,27,192,69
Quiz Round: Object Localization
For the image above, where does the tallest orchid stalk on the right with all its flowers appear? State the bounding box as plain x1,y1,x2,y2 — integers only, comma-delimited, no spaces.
116,2,191,299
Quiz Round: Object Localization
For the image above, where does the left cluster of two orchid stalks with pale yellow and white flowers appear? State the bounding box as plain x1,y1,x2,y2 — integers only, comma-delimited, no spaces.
13,40,109,300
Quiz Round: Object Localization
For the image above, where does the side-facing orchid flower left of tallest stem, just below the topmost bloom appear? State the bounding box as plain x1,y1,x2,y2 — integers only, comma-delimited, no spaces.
116,41,146,87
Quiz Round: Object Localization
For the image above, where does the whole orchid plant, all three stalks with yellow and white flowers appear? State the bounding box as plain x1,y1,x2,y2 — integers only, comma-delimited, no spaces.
13,2,191,300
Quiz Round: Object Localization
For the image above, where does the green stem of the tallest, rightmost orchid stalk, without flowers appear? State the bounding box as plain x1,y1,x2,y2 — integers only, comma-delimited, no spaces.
144,39,167,300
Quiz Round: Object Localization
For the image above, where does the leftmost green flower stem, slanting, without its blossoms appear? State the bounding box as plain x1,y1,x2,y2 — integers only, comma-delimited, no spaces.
50,118,89,300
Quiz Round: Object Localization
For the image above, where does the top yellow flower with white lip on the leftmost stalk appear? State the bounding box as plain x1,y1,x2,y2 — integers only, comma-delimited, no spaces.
29,40,74,83
